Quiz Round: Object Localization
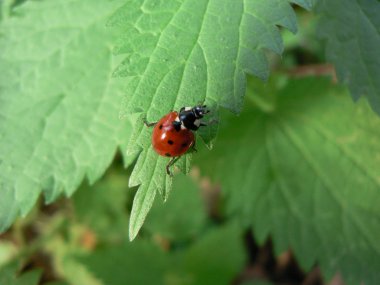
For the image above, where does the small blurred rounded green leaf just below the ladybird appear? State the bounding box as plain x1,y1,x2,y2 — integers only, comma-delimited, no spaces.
143,175,206,240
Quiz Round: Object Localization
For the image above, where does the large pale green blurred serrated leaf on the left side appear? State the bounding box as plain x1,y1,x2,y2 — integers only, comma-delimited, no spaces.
0,0,134,231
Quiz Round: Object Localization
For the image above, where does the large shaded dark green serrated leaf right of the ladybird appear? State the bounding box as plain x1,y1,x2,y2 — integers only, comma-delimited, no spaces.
198,78,380,284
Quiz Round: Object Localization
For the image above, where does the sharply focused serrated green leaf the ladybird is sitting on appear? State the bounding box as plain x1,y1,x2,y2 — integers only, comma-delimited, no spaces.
109,0,312,239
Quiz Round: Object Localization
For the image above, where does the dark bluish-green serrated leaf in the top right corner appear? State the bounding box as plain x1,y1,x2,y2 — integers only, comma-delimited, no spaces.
316,0,380,114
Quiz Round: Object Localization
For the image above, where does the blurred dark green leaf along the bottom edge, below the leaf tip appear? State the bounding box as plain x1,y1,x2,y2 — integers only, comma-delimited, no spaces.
77,223,244,285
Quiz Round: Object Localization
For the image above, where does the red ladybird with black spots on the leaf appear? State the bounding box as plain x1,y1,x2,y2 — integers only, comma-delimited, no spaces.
144,105,210,176
